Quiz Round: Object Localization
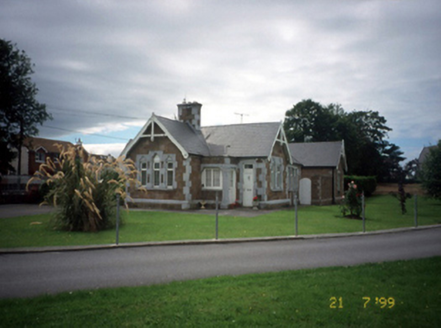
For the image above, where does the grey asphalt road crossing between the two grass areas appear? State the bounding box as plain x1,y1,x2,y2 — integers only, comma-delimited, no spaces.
0,228,441,298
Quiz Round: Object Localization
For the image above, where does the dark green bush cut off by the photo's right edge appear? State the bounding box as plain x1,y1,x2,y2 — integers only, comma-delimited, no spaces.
421,140,441,199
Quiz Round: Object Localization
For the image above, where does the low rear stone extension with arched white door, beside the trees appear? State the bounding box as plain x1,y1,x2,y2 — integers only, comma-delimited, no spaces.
289,140,347,205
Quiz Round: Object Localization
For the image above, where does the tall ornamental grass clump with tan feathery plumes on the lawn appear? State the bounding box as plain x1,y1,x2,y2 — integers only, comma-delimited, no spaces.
28,144,145,232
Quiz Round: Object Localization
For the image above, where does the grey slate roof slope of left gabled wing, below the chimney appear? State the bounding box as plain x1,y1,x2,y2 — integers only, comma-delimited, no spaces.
156,116,210,156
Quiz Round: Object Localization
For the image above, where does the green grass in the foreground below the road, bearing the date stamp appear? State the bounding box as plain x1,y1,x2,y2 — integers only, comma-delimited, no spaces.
0,257,441,327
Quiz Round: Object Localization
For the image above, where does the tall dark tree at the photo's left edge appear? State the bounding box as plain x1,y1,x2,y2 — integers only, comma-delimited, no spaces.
0,39,52,175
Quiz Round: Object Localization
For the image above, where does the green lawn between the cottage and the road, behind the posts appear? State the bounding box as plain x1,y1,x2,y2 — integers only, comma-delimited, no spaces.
0,196,441,248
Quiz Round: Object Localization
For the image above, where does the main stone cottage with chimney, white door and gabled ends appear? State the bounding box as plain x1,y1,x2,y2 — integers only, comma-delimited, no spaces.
121,101,301,209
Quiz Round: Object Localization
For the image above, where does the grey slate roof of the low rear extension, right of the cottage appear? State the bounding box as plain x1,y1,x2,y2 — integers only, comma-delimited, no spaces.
289,141,347,170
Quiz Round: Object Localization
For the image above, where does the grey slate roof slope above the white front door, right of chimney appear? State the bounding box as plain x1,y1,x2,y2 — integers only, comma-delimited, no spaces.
201,123,280,157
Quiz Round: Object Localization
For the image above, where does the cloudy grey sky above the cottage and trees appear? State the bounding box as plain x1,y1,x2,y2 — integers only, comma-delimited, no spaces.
0,0,441,159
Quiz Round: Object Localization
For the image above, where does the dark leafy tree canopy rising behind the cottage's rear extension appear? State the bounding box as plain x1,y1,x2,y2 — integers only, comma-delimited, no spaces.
284,99,405,181
